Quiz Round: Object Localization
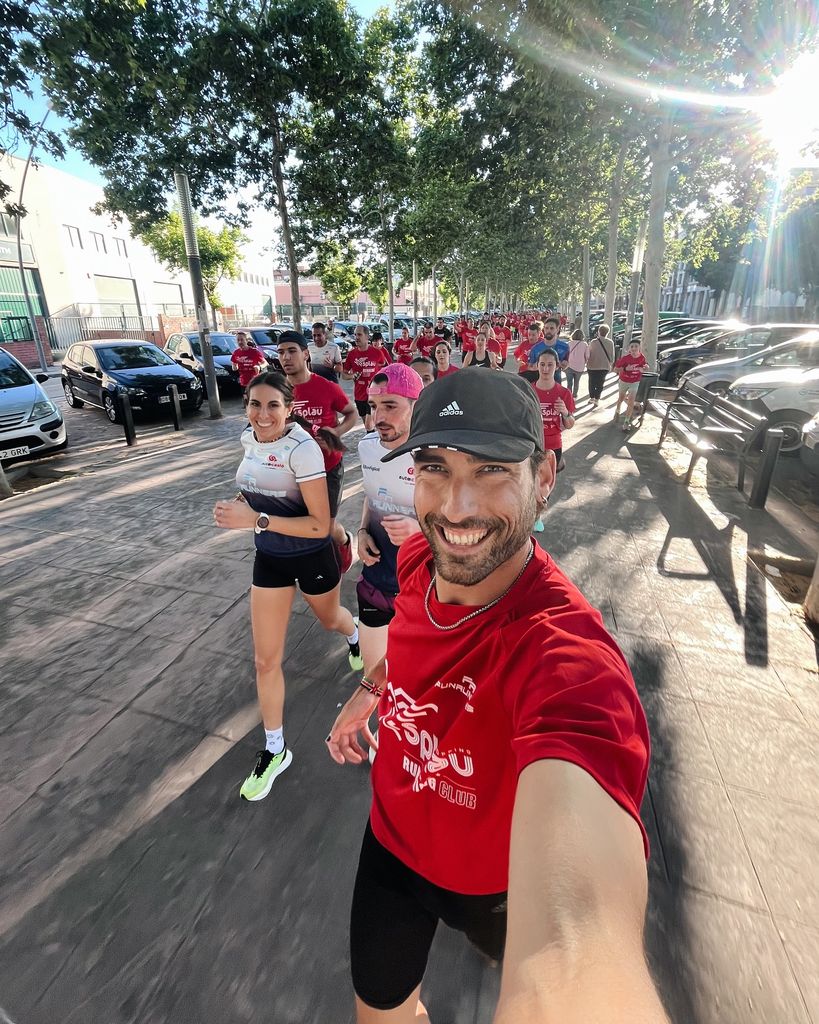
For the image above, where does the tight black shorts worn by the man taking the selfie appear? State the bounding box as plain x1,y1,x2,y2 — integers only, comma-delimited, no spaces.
350,822,507,1010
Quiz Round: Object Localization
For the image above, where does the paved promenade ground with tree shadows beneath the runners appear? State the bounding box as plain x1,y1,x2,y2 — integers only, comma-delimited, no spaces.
0,378,819,1024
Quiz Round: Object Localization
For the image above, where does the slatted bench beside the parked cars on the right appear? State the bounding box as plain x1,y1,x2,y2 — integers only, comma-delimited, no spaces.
645,381,781,508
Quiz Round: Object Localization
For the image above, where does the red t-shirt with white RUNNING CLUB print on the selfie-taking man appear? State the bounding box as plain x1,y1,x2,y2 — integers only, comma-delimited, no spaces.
371,534,649,895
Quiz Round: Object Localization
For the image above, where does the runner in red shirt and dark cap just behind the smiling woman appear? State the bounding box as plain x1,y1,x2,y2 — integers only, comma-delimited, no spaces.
278,331,356,572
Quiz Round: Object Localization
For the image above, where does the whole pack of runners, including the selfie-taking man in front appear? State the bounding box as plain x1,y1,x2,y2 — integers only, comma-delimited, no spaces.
214,316,666,1024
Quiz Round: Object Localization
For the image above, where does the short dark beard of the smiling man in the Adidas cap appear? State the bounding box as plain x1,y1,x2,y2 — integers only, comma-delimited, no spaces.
420,487,540,587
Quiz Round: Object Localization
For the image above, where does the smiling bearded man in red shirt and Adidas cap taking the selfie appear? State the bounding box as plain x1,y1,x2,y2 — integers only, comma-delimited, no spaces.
328,372,667,1024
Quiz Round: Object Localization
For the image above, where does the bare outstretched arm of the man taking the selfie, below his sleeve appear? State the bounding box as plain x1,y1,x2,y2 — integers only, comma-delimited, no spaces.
494,760,669,1024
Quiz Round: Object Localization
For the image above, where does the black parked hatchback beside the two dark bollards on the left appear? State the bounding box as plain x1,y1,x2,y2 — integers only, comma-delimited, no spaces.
60,338,204,423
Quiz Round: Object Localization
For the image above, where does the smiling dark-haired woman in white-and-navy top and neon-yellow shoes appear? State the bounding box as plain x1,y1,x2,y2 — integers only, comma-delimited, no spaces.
213,373,363,800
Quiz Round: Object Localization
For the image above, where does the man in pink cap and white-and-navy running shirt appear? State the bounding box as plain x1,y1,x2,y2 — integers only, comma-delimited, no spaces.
357,364,421,673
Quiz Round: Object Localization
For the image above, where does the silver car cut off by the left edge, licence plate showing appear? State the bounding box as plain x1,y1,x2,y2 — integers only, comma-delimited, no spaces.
0,348,68,462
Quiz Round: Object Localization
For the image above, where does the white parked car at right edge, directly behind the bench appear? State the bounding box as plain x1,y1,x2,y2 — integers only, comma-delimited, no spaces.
728,367,819,456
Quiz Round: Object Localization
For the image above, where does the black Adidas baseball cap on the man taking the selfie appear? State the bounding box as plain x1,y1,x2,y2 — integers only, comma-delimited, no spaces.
381,367,544,462
